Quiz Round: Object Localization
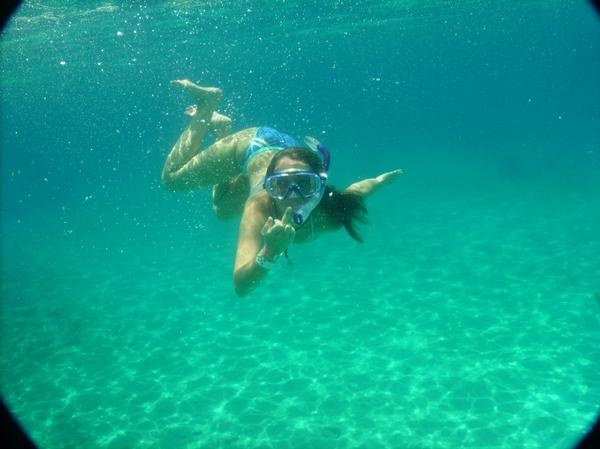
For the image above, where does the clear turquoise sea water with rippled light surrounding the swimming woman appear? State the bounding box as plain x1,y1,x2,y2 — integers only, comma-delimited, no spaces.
0,1,600,449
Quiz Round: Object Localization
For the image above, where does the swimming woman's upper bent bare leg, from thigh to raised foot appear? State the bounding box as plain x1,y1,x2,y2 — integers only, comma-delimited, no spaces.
161,80,254,190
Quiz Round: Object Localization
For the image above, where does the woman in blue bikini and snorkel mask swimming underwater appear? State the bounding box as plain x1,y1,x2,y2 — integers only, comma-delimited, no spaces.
162,80,402,296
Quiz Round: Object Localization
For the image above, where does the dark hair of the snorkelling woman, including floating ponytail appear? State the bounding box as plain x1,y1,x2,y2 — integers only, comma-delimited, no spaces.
265,147,368,242
